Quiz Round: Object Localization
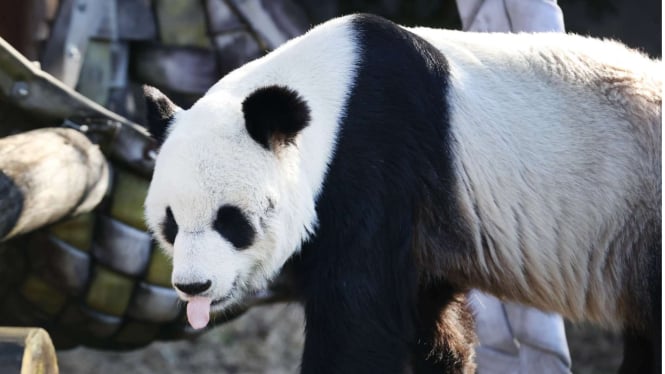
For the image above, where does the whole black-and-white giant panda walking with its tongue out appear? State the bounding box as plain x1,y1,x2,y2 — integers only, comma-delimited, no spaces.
145,15,663,374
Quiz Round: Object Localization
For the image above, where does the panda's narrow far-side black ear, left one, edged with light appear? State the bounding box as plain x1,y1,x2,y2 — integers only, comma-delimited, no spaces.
143,85,180,145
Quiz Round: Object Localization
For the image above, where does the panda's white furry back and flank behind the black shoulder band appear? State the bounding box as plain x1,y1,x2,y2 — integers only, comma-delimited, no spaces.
412,29,662,324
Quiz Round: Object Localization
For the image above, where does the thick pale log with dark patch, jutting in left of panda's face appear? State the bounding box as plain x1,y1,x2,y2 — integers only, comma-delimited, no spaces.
0,128,109,241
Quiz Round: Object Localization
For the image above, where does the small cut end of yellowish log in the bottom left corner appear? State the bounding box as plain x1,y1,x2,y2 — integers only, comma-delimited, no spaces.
0,327,58,374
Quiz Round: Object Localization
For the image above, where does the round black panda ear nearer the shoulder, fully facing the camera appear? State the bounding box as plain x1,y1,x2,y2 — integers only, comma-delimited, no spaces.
242,86,310,150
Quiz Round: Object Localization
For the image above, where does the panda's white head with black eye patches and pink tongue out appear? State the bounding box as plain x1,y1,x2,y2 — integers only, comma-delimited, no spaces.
145,85,313,327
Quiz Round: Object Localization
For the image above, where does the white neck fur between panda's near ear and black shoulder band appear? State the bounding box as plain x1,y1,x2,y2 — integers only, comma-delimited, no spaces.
276,19,358,200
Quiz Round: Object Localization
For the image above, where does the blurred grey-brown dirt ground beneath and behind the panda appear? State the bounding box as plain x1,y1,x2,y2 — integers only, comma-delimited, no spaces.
58,304,622,374
